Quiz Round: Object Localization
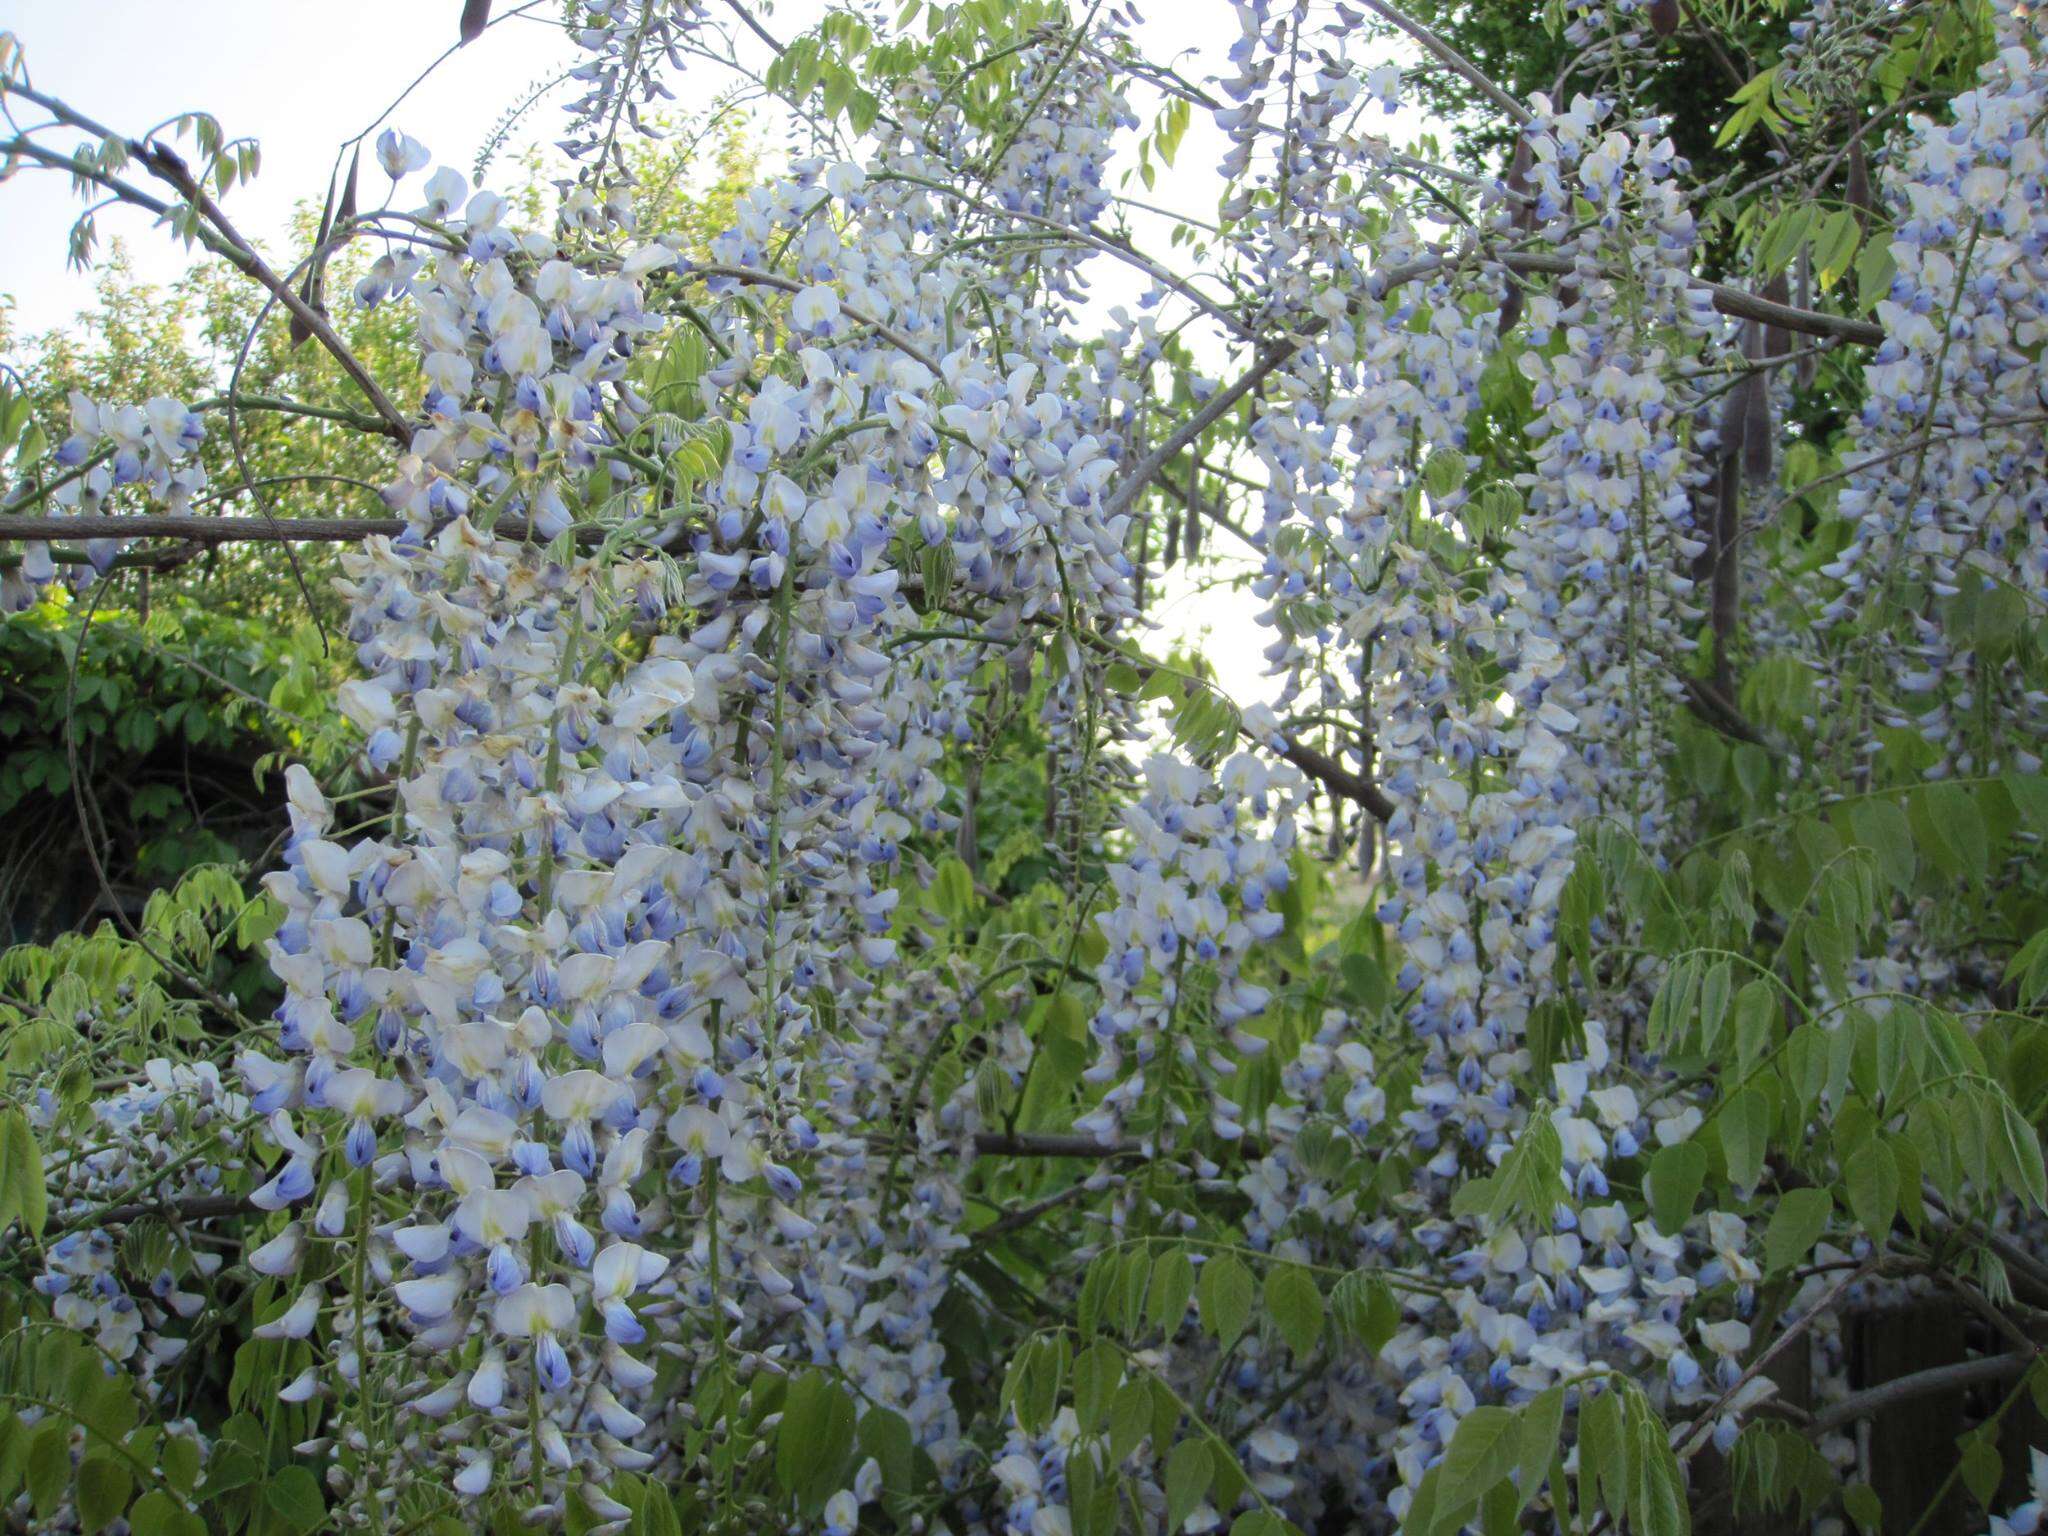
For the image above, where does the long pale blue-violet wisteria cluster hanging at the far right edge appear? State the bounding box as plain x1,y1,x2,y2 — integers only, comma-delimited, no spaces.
1827,33,2048,774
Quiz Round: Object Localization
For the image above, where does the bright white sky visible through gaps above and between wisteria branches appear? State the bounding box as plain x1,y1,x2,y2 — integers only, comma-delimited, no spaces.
0,0,1409,705
